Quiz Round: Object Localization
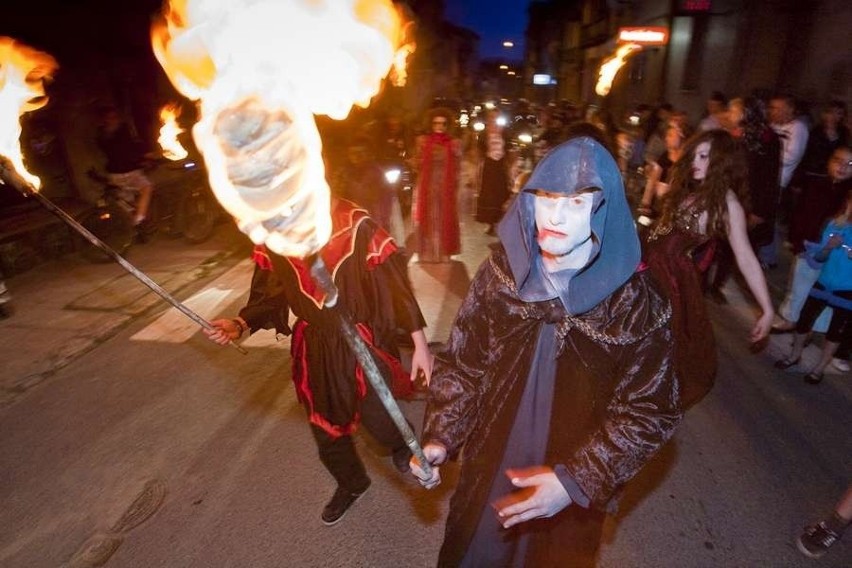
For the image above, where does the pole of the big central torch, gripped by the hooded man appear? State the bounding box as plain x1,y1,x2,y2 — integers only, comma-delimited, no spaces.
308,255,432,477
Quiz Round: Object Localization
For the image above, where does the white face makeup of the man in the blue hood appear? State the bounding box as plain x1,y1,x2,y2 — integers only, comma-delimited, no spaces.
533,188,600,272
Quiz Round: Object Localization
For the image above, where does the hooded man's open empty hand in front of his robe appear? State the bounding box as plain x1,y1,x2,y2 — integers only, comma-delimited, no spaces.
494,466,571,529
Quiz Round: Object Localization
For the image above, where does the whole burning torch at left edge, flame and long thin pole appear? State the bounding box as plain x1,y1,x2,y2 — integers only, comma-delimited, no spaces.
0,37,246,353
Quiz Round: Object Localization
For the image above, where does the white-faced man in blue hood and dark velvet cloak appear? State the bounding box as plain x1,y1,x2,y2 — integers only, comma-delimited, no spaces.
412,136,681,567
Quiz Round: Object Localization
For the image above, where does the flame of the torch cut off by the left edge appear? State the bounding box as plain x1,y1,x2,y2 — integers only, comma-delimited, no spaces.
0,37,59,189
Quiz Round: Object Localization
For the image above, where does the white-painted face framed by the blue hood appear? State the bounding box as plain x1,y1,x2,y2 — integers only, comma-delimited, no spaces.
535,190,597,258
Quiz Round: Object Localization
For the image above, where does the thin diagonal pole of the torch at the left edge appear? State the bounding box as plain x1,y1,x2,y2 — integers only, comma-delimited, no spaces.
0,156,248,355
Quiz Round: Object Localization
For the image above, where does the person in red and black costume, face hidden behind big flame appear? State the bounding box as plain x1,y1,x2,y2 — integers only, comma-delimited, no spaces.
205,198,432,525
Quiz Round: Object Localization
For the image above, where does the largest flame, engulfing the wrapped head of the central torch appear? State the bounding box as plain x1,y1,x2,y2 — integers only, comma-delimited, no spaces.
156,0,420,256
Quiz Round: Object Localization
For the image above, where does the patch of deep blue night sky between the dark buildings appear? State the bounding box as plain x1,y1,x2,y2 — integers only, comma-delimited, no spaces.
447,0,530,60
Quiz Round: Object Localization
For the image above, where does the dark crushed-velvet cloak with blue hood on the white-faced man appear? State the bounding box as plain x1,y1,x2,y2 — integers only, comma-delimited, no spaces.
423,137,681,566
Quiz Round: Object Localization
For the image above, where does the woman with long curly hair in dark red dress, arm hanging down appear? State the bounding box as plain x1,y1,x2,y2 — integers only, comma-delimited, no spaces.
645,130,775,407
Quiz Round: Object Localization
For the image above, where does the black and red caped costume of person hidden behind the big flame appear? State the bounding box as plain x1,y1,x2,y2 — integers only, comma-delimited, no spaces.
240,199,426,436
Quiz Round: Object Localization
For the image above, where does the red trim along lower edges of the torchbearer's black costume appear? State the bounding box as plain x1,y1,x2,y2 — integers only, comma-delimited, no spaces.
290,320,413,438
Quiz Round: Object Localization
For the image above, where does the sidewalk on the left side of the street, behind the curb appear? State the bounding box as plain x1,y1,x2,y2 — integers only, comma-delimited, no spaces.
0,222,250,407
